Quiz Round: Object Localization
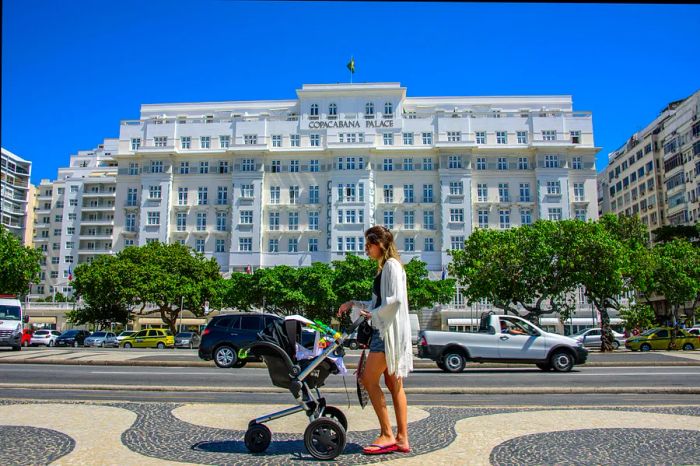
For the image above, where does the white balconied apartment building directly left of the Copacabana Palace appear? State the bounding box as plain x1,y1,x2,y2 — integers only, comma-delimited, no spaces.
30,139,118,298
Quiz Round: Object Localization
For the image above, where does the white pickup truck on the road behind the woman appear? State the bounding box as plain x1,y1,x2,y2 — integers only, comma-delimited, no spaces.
418,313,588,372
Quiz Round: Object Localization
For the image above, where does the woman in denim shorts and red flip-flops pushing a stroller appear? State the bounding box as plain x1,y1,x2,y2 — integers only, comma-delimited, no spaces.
338,226,413,455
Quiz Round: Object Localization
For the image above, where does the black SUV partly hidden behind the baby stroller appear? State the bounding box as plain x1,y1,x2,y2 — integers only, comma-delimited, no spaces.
199,312,282,368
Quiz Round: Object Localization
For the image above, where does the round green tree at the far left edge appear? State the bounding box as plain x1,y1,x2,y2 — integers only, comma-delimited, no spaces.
0,225,43,296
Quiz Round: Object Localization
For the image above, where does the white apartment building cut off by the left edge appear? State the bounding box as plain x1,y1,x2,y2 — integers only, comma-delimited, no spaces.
0,147,32,245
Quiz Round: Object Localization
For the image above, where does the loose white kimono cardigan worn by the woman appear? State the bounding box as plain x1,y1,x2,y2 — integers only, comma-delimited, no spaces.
353,258,413,377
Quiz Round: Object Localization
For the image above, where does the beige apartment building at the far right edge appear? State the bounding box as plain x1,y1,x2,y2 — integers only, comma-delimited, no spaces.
598,91,700,232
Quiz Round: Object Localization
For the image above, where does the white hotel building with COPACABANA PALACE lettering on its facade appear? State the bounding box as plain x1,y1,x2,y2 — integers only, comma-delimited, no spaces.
32,83,599,332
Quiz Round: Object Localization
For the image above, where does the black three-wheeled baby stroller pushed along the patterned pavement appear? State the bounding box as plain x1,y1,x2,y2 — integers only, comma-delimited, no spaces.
245,318,364,460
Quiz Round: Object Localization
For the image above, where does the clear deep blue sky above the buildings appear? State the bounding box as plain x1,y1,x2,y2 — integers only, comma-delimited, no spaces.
2,0,700,184
